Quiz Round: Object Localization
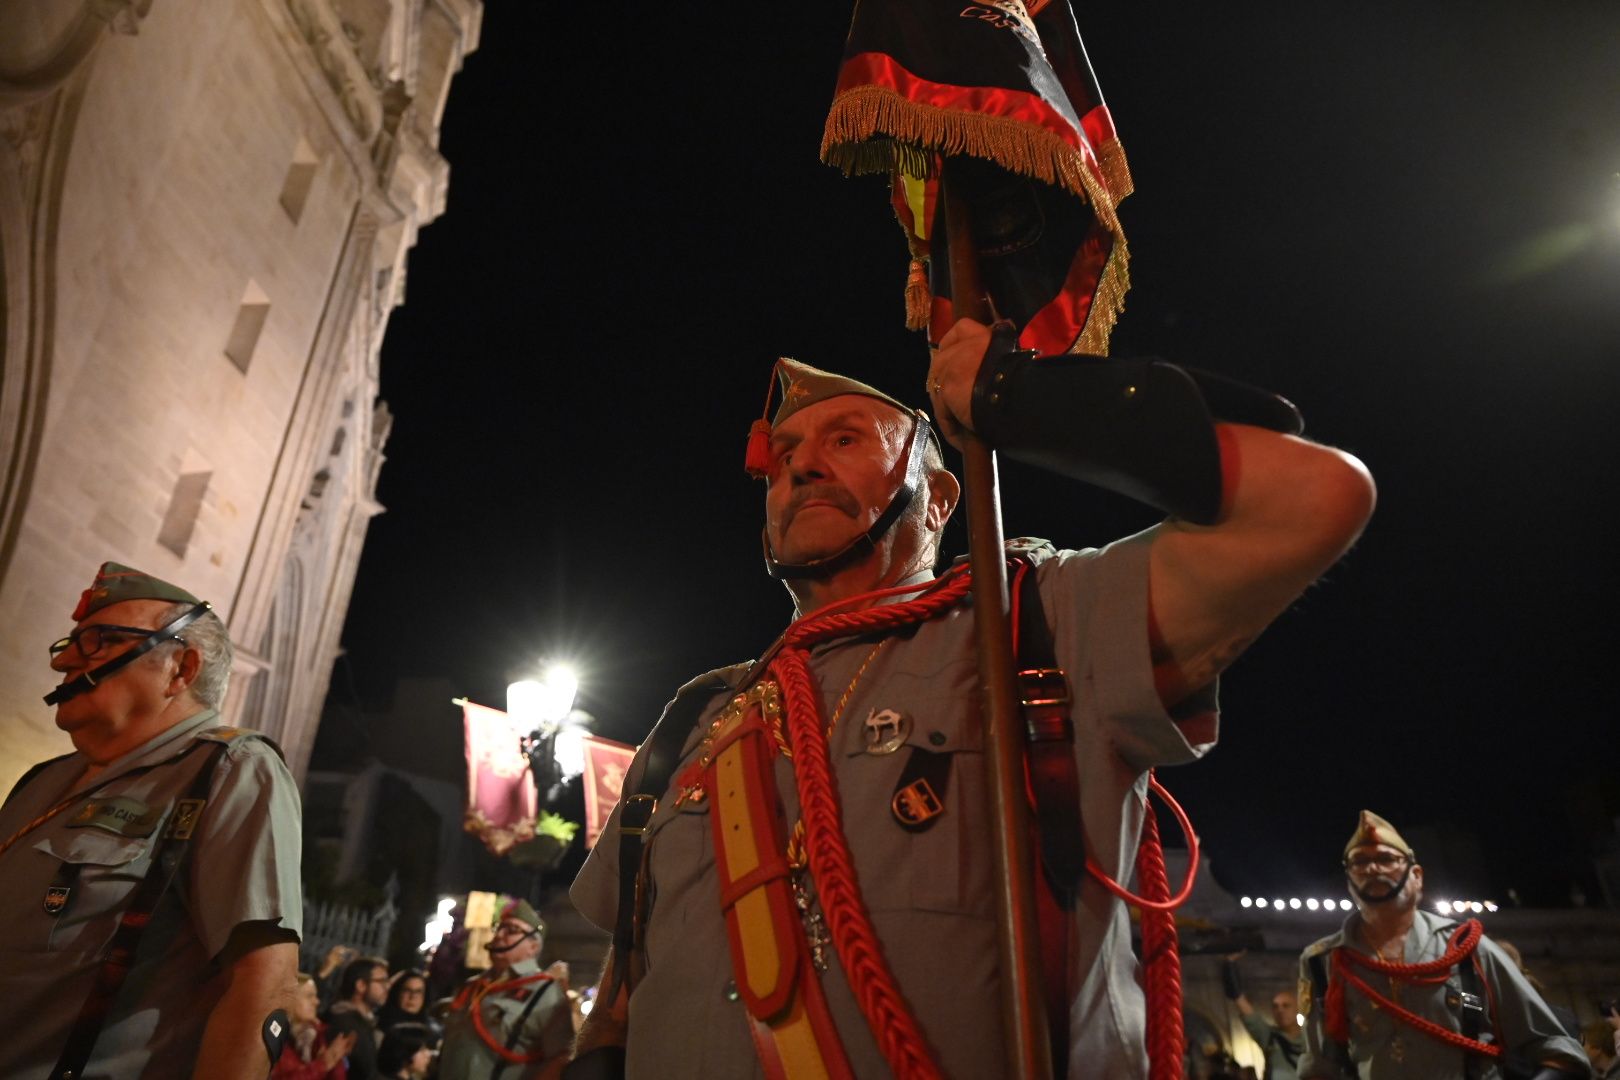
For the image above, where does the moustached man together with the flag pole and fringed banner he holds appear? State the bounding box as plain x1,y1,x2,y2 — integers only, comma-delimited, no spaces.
570,0,1374,1078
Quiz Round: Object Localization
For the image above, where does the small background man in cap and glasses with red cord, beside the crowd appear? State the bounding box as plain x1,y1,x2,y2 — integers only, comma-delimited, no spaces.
439,900,573,1080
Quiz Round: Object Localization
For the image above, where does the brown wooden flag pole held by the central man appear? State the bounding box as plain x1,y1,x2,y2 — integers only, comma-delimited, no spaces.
940,173,1068,1080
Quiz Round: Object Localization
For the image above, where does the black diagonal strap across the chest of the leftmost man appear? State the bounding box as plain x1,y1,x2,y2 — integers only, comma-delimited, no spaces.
50,743,225,1080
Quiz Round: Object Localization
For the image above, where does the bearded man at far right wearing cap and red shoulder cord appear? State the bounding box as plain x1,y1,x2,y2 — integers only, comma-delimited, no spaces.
1299,810,1591,1080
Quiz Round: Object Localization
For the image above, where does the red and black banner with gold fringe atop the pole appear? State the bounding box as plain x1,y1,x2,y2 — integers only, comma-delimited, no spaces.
821,0,1131,355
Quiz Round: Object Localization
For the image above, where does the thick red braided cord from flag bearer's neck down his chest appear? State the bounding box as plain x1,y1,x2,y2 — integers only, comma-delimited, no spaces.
773,573,970,1080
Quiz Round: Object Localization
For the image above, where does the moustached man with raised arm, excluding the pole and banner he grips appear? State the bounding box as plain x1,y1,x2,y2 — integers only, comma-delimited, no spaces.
572,321,1374,1080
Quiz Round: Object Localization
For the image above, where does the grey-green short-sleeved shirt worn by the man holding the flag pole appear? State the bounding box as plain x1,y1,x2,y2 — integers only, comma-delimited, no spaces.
572,533,1215,1080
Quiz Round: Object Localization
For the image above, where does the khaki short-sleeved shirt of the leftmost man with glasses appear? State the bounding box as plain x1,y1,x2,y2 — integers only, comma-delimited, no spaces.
0,709,303,1080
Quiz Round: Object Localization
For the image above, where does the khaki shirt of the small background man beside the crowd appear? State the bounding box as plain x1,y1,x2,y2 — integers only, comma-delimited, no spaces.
439,960,573,1080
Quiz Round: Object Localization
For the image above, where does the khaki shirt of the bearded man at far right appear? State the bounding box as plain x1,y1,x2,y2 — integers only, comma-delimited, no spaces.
1299,908,1591,1080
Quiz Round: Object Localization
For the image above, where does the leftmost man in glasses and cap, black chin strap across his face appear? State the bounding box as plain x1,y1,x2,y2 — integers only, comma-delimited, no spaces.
0,562,303,1080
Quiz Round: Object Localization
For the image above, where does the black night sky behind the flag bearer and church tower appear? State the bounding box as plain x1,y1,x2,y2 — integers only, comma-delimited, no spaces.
334,0,1620,902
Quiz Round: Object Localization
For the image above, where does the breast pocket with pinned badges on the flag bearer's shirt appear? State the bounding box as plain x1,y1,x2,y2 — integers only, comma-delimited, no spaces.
839,683,993,915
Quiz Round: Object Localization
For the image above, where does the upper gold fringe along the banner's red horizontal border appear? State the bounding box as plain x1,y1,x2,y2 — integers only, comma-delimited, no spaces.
821,86,1129,236
